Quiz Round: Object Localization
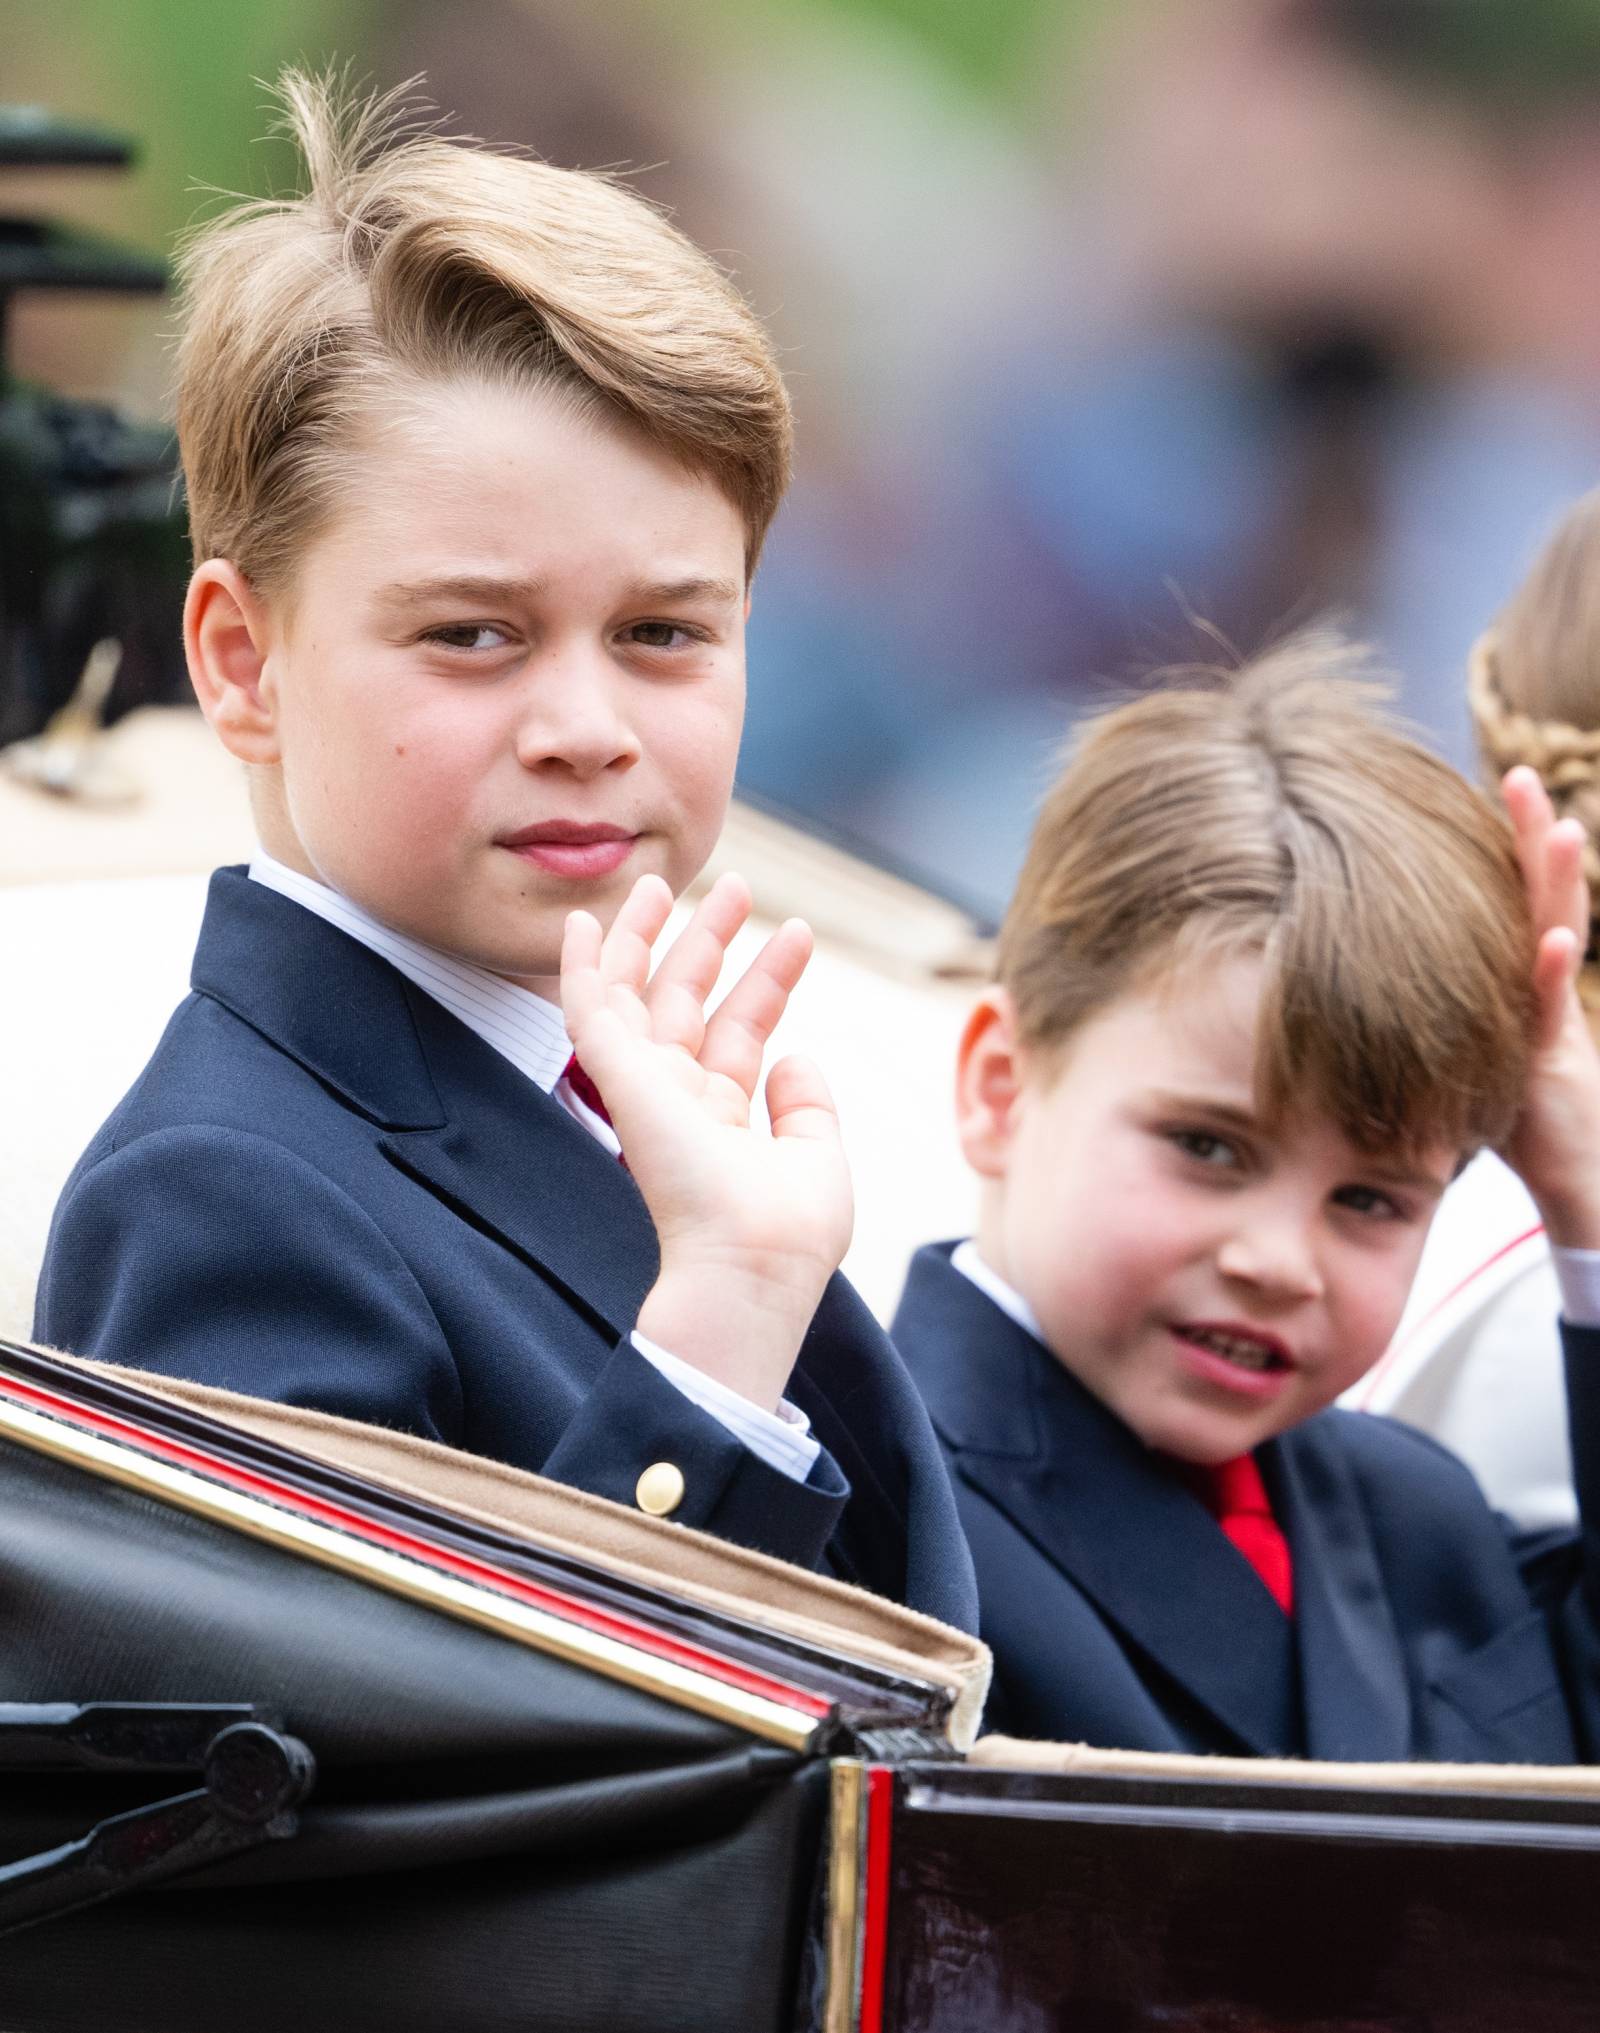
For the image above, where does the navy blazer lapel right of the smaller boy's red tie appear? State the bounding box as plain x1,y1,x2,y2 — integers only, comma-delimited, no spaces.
1260,1413,1411,1759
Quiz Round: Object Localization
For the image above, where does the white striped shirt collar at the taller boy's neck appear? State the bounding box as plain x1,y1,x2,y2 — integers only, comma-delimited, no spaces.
250,852,618,1151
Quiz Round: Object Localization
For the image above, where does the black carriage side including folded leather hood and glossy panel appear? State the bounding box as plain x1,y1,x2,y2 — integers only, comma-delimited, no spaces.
0,1346,1600,2033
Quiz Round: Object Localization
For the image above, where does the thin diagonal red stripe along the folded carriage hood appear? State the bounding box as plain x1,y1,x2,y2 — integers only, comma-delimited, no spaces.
0,1376,834,1718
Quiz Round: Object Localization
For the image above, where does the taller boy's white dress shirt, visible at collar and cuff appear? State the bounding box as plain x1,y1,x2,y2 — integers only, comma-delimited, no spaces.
250,852,821,1482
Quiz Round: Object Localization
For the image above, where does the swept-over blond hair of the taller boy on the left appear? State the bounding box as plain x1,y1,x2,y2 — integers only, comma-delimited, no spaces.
177,71,793,590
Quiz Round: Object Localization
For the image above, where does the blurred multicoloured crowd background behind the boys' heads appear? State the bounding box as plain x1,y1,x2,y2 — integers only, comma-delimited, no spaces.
0,0,1600,913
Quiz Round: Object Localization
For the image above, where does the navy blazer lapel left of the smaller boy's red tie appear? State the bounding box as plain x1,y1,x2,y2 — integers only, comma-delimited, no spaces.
895,1250,1301,1757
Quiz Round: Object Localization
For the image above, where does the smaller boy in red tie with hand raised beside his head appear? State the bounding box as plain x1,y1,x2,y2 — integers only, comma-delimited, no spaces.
895,636,1600,1763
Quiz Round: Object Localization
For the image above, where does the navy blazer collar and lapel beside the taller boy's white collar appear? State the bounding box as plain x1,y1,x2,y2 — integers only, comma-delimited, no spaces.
191,868,659,1336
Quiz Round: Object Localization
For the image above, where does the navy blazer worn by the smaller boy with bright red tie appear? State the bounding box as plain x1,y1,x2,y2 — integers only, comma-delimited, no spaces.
893,1244,1600,1765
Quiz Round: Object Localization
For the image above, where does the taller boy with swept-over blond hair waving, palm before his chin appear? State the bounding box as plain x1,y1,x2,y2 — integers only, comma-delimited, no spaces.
37,77,974,1622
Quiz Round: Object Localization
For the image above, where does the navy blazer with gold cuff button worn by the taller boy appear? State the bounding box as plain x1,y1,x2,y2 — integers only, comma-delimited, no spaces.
35,868,976,1628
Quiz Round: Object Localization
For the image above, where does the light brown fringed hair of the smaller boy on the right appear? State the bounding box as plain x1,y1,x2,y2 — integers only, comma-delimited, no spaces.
998,630,1533,1151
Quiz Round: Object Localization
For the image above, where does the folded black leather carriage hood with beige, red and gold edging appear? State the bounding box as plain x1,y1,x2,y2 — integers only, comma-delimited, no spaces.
0,1350,982,2033
